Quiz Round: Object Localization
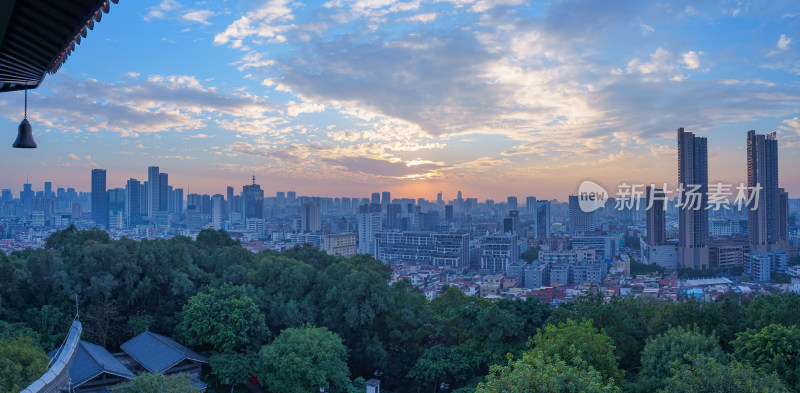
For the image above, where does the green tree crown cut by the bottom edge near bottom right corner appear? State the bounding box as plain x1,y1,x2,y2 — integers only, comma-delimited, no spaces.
659,356,791,393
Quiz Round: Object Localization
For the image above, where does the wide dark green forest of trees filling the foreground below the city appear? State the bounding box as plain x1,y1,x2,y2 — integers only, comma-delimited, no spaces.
0,228,800,393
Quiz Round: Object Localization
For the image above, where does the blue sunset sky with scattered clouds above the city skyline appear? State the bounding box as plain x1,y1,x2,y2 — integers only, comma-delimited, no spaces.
0,0,800,200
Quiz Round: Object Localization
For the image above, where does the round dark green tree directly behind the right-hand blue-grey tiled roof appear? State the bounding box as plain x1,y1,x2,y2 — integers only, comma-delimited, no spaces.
178,284,269,352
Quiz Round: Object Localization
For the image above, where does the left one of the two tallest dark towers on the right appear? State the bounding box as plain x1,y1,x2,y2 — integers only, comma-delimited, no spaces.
678,128,708,269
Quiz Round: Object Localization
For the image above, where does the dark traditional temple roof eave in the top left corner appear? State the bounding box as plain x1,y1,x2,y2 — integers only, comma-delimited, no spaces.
0,0,119,92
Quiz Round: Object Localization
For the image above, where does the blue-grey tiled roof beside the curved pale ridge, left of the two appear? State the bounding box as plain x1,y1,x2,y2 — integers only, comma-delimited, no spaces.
48,341,133,387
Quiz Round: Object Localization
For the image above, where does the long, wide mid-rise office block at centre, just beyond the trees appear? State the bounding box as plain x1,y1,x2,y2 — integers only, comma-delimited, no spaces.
374,231,469,270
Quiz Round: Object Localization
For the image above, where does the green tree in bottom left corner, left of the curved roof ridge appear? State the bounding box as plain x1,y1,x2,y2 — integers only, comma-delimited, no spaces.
0,336,50,392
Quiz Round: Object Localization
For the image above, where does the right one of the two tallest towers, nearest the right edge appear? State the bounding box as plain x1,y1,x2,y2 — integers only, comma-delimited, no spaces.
747,130,788,253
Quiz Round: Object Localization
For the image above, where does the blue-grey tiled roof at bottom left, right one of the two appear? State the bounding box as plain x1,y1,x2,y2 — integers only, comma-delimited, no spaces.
120,332,208,373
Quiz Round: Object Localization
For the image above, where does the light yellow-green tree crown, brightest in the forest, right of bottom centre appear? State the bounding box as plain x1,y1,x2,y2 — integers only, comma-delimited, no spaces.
529,319,625,386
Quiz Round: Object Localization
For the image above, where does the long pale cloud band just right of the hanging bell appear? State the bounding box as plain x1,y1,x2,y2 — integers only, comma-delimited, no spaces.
0,72,279,136
